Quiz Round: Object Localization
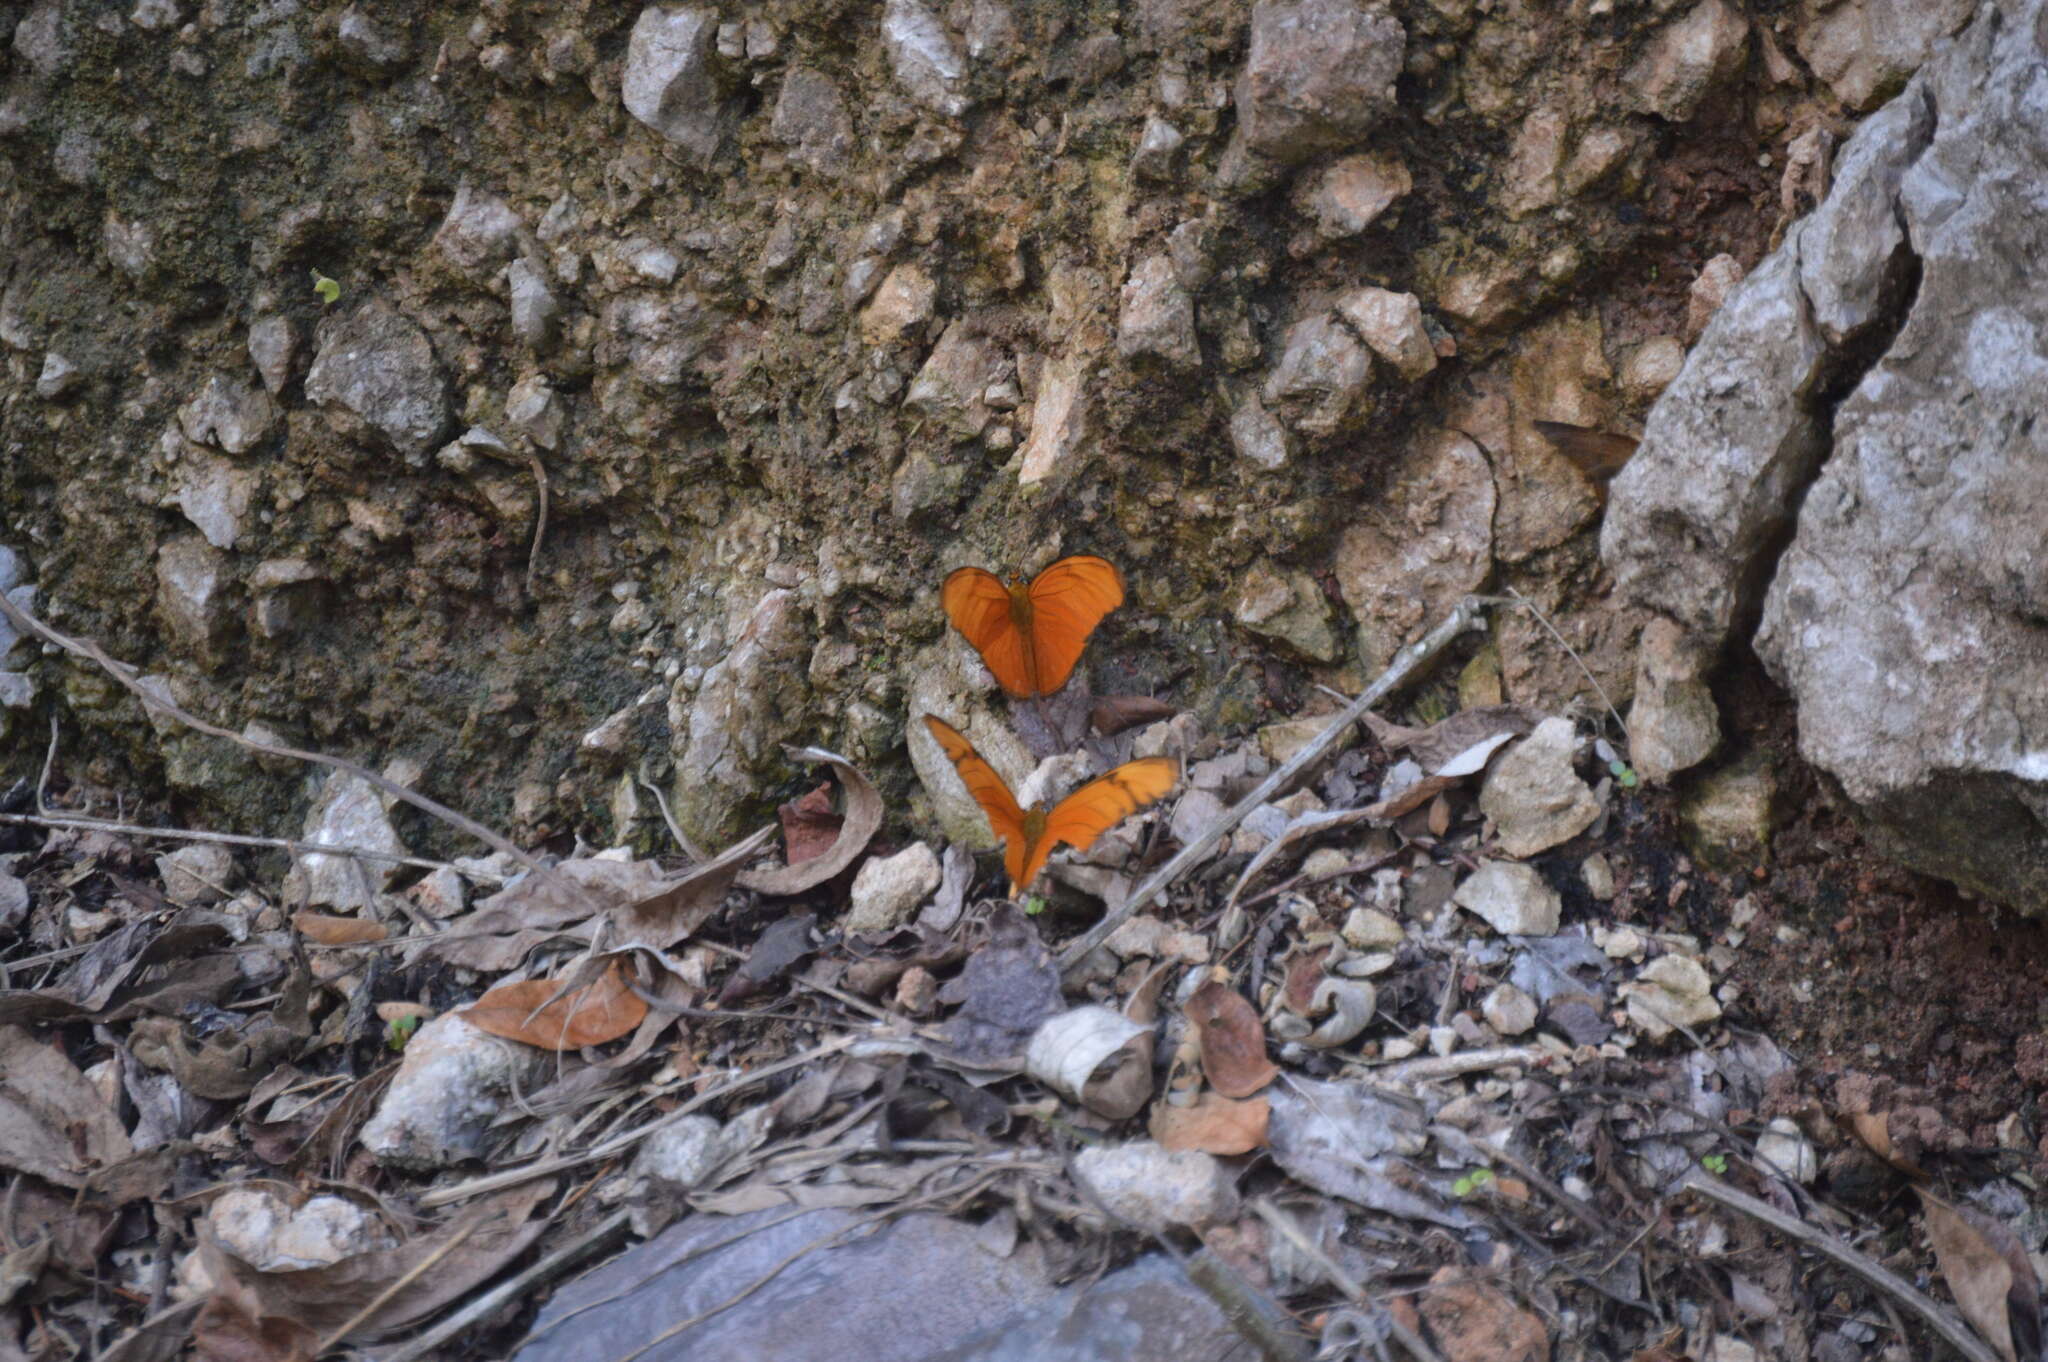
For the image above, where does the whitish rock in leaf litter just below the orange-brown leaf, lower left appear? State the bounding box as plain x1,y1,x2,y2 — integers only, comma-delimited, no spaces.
360,1012,549,1174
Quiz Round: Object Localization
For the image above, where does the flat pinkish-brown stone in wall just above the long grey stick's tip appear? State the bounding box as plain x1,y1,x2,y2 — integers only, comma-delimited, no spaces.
1335,430,1495,672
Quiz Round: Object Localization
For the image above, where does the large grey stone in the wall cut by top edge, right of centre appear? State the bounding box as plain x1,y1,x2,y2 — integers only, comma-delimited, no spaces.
1237,0,1407,162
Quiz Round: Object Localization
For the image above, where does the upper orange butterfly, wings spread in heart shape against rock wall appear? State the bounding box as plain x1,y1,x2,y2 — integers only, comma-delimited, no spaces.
938,553,1124,698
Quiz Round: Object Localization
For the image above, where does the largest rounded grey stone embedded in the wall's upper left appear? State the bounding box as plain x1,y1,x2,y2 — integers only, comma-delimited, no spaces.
305,303,449,457
